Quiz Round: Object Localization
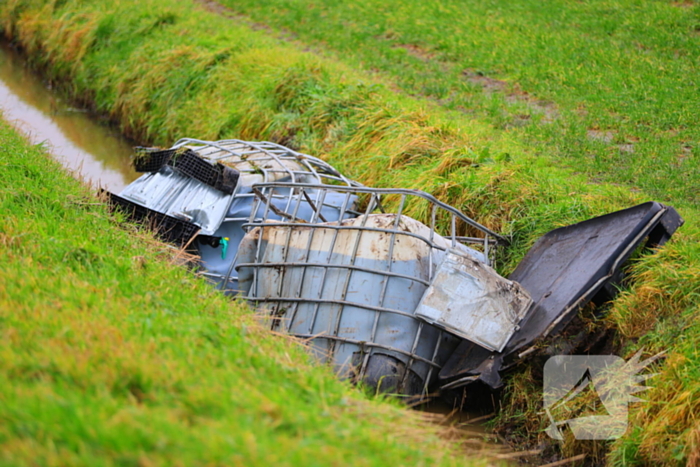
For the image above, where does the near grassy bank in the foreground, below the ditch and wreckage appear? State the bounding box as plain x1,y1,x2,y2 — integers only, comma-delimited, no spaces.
0,121,498,467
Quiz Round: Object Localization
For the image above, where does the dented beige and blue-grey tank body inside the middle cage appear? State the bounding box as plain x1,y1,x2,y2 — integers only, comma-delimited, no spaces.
239,214,458,393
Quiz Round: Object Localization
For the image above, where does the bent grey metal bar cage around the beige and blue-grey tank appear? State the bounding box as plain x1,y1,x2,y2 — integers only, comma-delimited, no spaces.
232,183,507,396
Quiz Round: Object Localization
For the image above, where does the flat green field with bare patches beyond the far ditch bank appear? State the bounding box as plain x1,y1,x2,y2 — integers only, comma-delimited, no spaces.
220,0,700,206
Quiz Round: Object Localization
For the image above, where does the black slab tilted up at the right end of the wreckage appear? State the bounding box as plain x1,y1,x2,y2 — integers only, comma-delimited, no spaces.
440,202,683,389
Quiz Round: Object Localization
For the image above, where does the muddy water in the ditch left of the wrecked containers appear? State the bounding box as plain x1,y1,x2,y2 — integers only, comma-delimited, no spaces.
0,41,138,192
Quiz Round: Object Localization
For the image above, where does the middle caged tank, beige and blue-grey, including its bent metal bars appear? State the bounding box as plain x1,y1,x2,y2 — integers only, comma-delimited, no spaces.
236,184,499,395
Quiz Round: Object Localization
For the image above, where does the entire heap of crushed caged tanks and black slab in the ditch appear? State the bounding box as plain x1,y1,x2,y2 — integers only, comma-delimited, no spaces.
106,139,683,397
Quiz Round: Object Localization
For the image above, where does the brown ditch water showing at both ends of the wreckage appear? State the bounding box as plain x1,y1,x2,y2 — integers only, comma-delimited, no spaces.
5,32,636,464
